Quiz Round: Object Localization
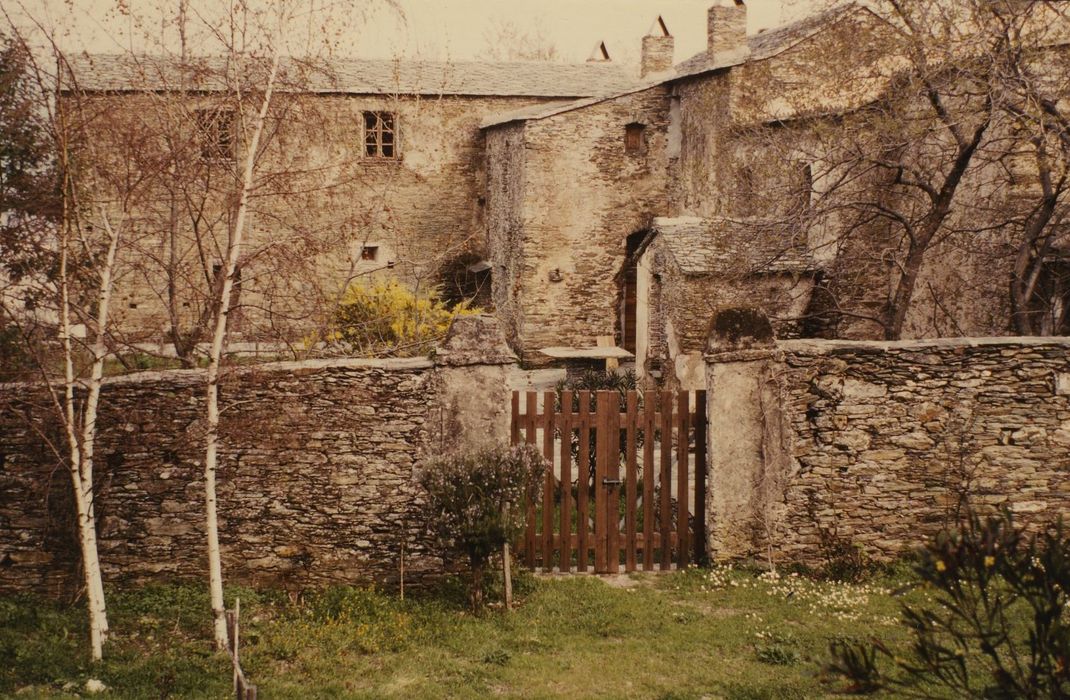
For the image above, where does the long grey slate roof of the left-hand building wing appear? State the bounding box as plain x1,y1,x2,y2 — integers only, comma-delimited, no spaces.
60,55,635,97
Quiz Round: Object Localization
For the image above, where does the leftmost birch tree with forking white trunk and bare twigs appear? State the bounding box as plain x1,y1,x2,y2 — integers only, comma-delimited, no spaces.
0,28,160,660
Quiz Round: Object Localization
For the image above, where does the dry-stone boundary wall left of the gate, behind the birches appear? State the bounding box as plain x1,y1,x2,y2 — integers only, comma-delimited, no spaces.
0,317,513,595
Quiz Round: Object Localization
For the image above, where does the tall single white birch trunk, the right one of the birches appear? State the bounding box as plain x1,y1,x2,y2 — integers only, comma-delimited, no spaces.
204,53,279,651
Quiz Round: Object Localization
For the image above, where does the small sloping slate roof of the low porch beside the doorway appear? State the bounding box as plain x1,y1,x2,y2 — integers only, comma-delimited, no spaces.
654,216,819,276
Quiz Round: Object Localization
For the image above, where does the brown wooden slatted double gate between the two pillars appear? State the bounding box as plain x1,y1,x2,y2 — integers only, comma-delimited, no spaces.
511,391,706,574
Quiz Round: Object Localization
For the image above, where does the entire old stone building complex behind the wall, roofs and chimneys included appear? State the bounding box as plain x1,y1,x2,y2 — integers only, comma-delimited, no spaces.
64,0,1067,386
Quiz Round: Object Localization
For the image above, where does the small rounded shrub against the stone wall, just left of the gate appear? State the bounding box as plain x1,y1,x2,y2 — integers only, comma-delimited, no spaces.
419,445,546,608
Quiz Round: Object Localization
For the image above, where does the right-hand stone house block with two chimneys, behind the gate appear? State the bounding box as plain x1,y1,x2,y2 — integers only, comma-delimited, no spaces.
484,0,1070,387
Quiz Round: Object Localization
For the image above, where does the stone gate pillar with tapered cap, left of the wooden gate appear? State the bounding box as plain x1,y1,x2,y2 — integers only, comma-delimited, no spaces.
428,315,517,454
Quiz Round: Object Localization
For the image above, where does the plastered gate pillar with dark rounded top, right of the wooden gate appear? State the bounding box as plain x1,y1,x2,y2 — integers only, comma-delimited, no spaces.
705,308,791,562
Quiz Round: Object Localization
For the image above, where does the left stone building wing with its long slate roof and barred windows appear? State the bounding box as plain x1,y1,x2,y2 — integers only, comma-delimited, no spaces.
63,56,631,351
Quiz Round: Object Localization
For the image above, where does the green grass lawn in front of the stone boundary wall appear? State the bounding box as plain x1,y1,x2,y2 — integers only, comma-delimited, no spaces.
0,569,945,698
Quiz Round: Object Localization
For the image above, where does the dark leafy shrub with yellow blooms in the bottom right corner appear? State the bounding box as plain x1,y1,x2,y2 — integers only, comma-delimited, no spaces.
832,513,1070,698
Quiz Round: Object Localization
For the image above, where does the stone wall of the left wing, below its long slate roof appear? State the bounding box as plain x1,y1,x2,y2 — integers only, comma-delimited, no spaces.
75,93,547,340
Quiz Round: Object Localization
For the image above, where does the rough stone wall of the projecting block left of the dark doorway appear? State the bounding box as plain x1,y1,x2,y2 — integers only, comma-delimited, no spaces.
487,86,668,362
